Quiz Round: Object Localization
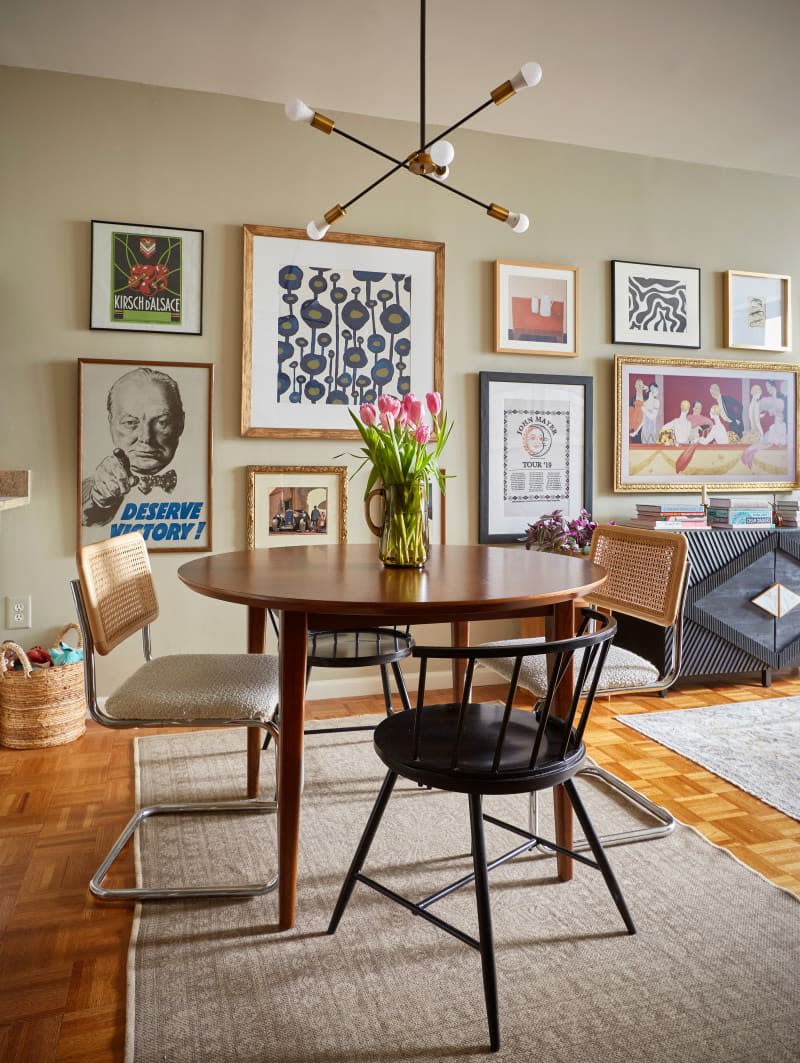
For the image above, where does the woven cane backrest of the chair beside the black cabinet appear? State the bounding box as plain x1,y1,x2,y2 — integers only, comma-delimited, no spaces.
588,524,688,627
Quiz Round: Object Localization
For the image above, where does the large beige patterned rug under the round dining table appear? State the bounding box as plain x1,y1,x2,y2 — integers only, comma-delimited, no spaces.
126,718,800,1063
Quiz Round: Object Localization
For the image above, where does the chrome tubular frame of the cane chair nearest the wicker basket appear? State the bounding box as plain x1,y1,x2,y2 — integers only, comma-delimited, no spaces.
70,537,278,901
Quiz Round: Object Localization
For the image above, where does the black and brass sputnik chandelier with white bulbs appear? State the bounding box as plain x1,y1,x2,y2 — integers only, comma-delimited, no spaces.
286,0,542,240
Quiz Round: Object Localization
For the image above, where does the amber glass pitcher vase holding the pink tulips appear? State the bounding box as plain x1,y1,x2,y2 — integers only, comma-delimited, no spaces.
364,479,430,569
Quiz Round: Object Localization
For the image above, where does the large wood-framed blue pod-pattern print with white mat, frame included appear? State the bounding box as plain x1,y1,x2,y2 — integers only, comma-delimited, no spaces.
241,225,444,439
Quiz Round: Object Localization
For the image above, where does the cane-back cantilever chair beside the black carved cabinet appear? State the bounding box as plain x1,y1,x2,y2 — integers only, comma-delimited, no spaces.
490,524,690,845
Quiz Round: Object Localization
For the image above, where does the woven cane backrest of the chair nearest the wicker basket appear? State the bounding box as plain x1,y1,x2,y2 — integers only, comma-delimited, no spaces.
78,532,158,656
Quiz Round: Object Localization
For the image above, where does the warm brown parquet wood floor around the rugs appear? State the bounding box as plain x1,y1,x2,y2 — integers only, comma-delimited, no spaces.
0,676,800,1063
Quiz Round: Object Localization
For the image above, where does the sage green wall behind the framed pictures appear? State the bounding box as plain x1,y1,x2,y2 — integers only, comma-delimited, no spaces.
0,68,800,693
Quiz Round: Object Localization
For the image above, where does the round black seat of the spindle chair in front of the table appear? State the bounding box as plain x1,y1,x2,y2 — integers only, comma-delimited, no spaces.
374,703,586,794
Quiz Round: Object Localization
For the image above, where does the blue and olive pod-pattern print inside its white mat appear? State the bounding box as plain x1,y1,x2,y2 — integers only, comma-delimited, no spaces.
275,264,413,406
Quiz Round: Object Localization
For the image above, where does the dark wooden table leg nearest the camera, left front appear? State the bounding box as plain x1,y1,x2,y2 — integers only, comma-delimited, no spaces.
277,611,308,930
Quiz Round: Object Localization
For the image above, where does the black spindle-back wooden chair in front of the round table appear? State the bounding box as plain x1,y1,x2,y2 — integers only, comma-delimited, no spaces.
328,609,635,1051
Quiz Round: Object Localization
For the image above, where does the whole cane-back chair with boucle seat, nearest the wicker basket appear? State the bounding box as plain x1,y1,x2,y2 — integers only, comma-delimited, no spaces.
71,533,278,900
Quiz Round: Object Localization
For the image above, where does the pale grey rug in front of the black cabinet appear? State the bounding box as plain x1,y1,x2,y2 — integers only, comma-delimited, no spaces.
616,697,800,820
